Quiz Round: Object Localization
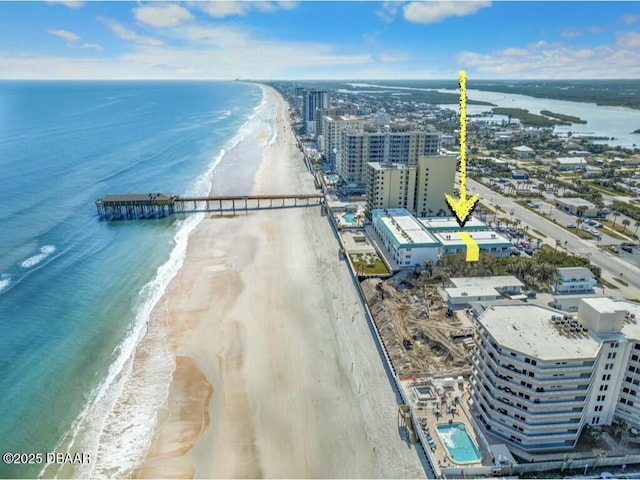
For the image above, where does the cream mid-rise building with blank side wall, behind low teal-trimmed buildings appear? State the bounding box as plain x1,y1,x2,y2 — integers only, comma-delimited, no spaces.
365,156,457,217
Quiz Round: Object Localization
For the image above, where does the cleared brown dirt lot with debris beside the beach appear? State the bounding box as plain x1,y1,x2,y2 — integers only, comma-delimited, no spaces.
361,275,474,380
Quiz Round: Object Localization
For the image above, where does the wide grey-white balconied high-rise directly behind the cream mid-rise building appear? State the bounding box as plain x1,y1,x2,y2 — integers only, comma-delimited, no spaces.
336,122,440,183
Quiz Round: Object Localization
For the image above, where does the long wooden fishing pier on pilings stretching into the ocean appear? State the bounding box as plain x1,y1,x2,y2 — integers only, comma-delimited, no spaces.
96,193,325,220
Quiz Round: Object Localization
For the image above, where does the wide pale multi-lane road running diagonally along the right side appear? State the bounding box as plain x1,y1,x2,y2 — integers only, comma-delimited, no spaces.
467,178,640,298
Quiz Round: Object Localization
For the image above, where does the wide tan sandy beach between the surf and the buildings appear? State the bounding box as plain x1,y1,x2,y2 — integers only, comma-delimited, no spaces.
132,87,424,478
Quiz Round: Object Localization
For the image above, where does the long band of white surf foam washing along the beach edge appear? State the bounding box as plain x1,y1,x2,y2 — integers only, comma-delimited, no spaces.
40,88,266,478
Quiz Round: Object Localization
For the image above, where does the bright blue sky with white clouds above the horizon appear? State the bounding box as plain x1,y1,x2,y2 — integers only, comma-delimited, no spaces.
0,0,640,80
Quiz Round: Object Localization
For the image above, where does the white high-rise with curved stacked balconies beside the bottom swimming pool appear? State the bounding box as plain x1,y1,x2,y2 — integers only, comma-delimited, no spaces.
471,298,640,453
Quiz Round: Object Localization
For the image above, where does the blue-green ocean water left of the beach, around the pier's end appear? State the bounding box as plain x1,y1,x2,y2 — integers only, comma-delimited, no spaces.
0,81,262,477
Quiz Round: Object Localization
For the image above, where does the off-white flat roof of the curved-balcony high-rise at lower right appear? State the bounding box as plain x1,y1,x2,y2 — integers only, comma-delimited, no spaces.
478,303,600,360
